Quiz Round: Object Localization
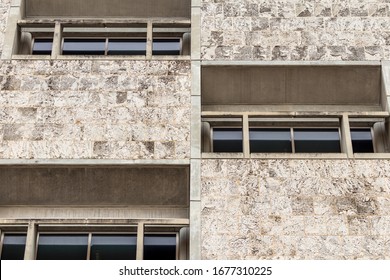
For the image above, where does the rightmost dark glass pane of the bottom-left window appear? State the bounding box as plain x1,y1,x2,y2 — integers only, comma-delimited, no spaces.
144,234,176,260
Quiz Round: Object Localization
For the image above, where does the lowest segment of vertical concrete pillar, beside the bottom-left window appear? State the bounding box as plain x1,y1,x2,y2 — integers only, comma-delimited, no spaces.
190,201,202,260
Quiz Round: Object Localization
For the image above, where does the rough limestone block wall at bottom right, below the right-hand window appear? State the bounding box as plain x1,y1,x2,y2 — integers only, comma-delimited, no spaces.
201,159,390,259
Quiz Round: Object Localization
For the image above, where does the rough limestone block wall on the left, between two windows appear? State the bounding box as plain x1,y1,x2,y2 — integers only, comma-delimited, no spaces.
0,60,191,159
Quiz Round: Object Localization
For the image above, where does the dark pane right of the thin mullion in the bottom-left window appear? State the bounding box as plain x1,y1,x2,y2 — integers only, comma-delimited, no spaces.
90,235,137,260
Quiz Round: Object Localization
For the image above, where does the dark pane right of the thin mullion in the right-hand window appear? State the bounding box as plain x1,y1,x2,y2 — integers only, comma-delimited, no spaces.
294,128,341,153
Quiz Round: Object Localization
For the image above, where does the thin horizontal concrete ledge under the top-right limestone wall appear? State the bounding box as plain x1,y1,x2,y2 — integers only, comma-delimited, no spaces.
202,60,381,66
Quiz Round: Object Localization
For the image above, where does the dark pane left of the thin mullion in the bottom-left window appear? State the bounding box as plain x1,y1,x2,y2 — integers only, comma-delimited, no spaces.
37,234,88,260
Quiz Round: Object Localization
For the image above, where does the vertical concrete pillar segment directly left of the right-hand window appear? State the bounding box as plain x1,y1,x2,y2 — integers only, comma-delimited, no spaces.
191,96,202,158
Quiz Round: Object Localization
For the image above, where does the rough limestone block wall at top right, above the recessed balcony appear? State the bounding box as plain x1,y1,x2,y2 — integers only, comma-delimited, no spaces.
201,0,390,61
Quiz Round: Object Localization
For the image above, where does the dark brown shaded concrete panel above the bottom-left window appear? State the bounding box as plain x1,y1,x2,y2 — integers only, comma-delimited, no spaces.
0,167,189,207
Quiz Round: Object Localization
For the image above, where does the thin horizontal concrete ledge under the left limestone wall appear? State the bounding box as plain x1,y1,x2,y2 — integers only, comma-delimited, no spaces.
0,159,190,166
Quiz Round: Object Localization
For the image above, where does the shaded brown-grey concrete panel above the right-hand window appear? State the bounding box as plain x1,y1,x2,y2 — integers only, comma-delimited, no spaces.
202,66,381,106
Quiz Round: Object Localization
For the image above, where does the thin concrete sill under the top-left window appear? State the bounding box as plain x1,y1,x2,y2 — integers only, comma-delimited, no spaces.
12,54,191,61
